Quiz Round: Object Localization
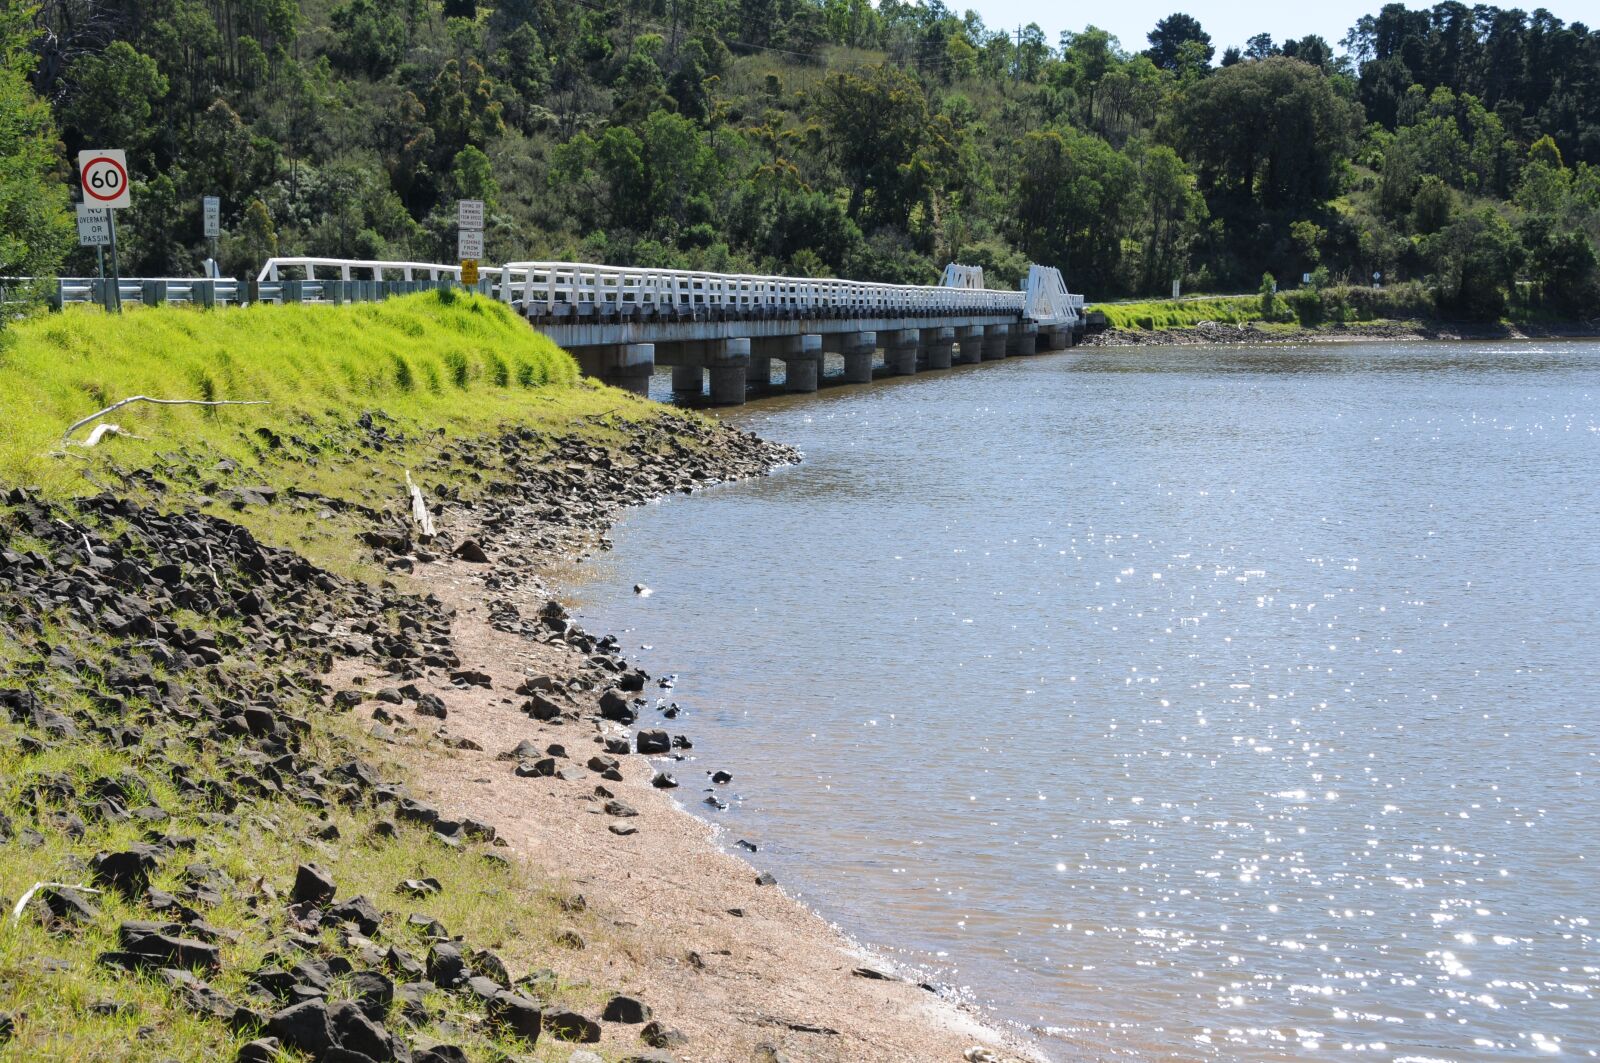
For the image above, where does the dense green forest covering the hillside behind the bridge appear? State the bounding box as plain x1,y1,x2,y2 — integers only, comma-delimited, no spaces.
0,0,1600,319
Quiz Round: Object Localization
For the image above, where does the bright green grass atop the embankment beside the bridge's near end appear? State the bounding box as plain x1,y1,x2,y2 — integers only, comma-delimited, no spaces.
0,291,684,575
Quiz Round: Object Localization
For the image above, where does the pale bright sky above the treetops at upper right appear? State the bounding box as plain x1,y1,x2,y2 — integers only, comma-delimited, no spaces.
946,0,1600,58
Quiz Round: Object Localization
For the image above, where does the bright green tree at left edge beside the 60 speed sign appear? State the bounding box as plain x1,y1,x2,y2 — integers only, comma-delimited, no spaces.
0,5,72,302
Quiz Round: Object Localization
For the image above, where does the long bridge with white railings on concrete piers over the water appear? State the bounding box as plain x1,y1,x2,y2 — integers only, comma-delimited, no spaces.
21,258,1083,405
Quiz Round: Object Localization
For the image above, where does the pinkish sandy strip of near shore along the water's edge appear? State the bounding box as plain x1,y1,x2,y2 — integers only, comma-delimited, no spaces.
334,427,1043,1063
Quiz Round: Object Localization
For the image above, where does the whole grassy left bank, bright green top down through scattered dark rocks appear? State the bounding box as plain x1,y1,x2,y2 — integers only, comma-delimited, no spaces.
0,293,707,1063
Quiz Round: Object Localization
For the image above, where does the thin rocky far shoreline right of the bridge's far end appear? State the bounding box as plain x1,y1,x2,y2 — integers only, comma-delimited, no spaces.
1080,322,1600,347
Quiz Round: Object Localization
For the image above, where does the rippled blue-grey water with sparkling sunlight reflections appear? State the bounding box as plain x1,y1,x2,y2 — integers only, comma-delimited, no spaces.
573,343,1600,1060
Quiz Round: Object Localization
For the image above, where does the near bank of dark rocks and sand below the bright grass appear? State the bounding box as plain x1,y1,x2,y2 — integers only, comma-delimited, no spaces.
0,408,1024,1063
